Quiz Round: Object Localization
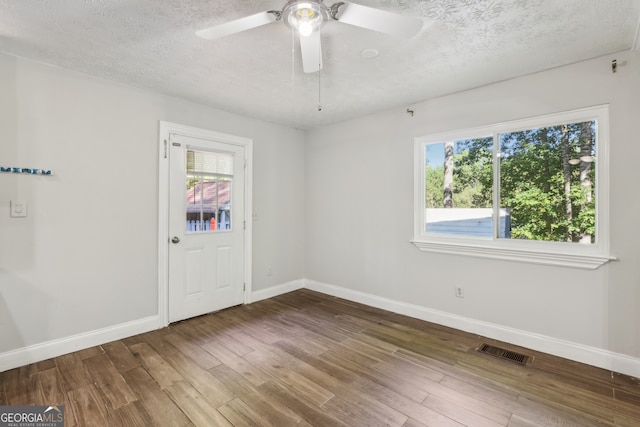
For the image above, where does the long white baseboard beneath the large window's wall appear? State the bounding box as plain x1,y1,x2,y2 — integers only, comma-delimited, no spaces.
304,279,640,377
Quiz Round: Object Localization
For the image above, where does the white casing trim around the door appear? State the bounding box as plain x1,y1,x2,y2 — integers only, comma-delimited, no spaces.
158,121,253,328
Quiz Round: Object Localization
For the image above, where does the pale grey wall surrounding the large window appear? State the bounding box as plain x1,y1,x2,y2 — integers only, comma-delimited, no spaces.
305,53,640,372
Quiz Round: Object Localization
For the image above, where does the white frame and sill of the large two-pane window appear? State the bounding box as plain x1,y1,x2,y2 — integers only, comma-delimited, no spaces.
411,105,615,269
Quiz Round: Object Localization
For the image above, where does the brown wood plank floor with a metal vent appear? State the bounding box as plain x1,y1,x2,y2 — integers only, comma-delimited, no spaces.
0,290,640,427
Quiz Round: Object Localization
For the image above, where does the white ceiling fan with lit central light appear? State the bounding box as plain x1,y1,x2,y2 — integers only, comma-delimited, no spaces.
196,0,423,73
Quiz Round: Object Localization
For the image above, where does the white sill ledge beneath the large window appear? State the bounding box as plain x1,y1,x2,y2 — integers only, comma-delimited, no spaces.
411,240,616,270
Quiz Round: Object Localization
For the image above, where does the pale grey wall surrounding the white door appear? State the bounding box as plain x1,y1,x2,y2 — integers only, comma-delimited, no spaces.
0,55,304,360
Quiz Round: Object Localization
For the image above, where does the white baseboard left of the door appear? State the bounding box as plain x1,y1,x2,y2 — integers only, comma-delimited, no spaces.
0,316,159,372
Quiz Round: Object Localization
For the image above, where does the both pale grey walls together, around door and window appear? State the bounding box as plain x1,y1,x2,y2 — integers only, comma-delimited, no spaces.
0,48,640,378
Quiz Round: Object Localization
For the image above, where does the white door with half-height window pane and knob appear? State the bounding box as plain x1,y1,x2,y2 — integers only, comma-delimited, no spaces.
168,134,245,322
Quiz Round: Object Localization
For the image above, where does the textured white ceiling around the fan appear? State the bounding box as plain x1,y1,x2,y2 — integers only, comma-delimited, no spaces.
0,0,640,129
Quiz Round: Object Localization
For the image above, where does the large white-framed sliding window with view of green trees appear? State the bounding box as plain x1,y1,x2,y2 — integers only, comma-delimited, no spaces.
412,105,613,269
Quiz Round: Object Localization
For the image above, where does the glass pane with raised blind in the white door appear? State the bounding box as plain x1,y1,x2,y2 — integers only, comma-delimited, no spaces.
186,149,233,233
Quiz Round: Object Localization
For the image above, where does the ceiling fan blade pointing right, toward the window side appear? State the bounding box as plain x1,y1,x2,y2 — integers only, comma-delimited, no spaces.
336,3,423,38
